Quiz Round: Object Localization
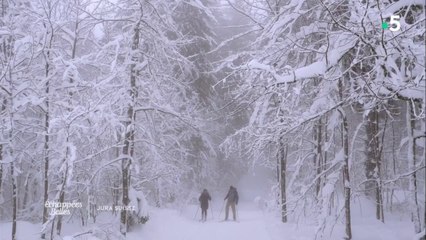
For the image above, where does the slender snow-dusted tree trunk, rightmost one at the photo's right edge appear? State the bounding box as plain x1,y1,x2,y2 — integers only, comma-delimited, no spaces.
406,102,422,233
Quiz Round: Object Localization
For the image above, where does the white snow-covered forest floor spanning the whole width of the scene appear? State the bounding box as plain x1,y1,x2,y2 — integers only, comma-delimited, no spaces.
0,203,414,240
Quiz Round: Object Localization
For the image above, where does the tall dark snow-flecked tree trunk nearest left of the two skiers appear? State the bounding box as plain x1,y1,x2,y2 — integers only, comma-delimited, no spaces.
120,22,140,236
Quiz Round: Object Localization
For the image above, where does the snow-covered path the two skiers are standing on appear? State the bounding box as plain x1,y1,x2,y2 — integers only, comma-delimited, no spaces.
129,204,272,240
